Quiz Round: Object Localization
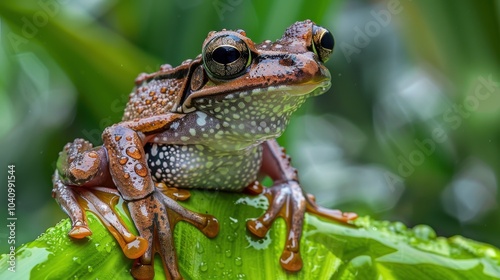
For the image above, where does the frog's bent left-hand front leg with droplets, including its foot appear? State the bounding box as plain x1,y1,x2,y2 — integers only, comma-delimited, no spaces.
103,114,219,279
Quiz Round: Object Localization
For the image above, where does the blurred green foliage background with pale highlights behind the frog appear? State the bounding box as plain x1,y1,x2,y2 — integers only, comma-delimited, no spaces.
0,0,500,253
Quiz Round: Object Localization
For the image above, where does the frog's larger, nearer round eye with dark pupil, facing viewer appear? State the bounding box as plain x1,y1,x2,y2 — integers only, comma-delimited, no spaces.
203,34,251,79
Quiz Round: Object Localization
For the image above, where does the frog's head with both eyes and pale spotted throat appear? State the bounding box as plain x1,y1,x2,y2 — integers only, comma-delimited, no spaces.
179,20,334,140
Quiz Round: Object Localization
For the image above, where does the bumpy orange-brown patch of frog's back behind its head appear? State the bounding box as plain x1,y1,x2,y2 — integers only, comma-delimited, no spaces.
122,60,192,121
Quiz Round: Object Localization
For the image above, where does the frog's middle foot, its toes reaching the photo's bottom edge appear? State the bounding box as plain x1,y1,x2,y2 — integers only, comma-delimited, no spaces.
128,188,219,279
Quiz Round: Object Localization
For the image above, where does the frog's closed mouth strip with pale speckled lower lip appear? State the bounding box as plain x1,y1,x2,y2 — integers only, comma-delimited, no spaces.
182,79,331,113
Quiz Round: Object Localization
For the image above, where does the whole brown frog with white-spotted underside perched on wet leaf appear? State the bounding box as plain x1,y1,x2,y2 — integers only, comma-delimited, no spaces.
52,20,357,279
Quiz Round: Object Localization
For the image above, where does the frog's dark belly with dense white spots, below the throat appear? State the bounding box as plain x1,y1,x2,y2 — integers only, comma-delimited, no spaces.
145,144,262,191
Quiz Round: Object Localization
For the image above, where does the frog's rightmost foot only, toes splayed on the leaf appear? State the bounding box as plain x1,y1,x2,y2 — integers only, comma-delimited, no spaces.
247,180,357,272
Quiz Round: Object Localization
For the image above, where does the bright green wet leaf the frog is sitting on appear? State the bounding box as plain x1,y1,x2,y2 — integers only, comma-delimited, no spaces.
0,190,500,279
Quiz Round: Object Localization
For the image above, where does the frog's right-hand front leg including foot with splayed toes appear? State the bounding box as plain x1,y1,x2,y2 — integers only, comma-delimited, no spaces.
247,140,357,271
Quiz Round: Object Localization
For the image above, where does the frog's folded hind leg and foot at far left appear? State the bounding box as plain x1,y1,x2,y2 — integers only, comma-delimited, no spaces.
52,139,147,259
